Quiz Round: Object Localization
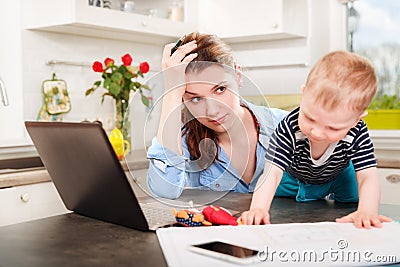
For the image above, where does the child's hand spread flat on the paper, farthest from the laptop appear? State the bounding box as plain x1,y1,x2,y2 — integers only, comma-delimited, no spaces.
336,210,392,229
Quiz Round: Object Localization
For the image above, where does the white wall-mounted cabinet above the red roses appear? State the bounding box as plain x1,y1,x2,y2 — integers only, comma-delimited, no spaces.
22,0,195,44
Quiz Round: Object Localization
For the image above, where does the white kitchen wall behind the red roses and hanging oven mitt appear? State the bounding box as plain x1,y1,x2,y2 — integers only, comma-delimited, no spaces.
22,31,162,148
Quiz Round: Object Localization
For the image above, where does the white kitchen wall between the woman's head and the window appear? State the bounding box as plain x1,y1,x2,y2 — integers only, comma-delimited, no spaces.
232,0,346,95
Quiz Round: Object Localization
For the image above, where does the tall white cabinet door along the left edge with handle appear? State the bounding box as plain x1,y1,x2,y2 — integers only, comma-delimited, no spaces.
0,1,29,147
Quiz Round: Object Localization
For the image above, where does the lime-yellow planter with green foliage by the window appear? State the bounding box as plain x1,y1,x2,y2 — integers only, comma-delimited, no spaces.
363,94,400,130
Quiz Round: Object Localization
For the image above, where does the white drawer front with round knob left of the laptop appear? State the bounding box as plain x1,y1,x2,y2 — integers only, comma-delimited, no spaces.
0,182,68,226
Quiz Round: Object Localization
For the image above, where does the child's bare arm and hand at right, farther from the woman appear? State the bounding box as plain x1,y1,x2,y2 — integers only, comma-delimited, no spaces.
336,167,391,229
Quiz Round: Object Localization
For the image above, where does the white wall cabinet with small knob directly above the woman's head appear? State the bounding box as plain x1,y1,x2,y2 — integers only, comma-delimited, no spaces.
199,0,309,43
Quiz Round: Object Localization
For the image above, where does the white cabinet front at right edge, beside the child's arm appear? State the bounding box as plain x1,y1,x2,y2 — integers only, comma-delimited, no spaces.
378,168,400,205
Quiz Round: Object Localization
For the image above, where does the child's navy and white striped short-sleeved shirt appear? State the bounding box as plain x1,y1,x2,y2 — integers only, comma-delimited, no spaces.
265,108,376,184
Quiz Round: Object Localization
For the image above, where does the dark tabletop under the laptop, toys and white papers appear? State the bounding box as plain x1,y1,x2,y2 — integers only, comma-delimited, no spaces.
0,188,400,267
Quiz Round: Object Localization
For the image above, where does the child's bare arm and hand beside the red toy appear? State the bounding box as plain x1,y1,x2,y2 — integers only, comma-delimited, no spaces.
240,163,283,225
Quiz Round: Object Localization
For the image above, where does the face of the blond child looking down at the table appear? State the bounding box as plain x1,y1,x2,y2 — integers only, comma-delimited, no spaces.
299,91,362,143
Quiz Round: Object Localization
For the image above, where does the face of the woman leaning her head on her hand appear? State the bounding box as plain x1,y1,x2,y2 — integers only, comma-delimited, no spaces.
183,65,241,133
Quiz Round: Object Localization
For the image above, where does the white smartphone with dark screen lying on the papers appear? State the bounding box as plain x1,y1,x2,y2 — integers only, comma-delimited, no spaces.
189,241,260,264
